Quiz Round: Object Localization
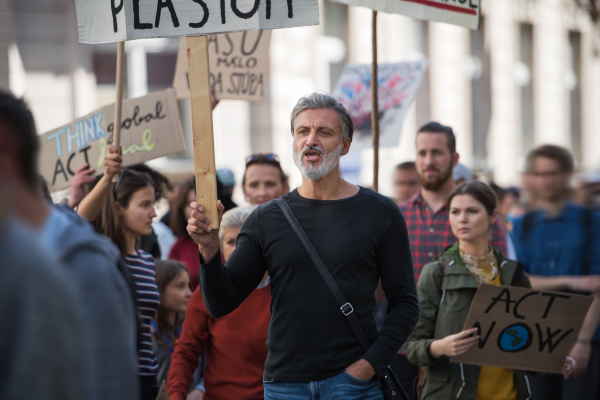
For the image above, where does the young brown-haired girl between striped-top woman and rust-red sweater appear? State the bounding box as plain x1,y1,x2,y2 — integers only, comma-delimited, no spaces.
152,261,192,386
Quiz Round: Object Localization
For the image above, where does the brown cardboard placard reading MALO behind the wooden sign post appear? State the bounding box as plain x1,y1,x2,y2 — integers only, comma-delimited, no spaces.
173,31,271,101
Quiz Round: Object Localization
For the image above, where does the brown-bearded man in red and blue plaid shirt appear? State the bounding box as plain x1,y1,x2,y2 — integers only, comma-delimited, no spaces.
399,122,507,280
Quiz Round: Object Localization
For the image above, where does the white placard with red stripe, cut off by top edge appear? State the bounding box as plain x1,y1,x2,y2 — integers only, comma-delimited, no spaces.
332,0,481,30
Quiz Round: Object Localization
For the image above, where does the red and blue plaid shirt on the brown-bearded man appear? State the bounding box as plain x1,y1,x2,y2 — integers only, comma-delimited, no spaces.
398,191,507,281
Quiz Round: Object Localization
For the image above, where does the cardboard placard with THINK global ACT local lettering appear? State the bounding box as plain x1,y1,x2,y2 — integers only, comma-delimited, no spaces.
39,89,185,190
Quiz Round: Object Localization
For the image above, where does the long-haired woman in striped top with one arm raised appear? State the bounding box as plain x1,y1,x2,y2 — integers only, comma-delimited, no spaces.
77,146,160,400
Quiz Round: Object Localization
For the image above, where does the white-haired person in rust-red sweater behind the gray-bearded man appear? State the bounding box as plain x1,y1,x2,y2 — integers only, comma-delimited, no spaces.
167,207,271,400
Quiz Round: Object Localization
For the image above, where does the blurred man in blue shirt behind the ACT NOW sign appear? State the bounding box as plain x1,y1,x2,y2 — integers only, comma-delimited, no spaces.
513,145,600,400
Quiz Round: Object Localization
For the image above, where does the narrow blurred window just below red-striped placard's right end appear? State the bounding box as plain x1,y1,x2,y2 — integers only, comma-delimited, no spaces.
469,19,492,173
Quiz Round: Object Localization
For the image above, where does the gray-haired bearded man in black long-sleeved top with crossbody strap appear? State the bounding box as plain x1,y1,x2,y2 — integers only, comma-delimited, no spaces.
188,93,419,400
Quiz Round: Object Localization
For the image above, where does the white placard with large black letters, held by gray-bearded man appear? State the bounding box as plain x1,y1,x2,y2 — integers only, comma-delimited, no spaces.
76,0,319,43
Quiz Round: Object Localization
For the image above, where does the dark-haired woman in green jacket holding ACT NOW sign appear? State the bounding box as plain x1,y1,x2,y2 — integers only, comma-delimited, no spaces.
404,181,573,400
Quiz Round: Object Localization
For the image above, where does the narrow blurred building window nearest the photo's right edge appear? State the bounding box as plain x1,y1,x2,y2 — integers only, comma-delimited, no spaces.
565,32,583,162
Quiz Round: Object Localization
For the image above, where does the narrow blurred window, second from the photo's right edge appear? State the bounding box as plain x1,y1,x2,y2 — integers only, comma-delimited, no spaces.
515,24,534,156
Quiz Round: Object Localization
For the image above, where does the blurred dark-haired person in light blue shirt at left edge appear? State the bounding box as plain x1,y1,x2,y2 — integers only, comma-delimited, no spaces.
0,92,139,400
